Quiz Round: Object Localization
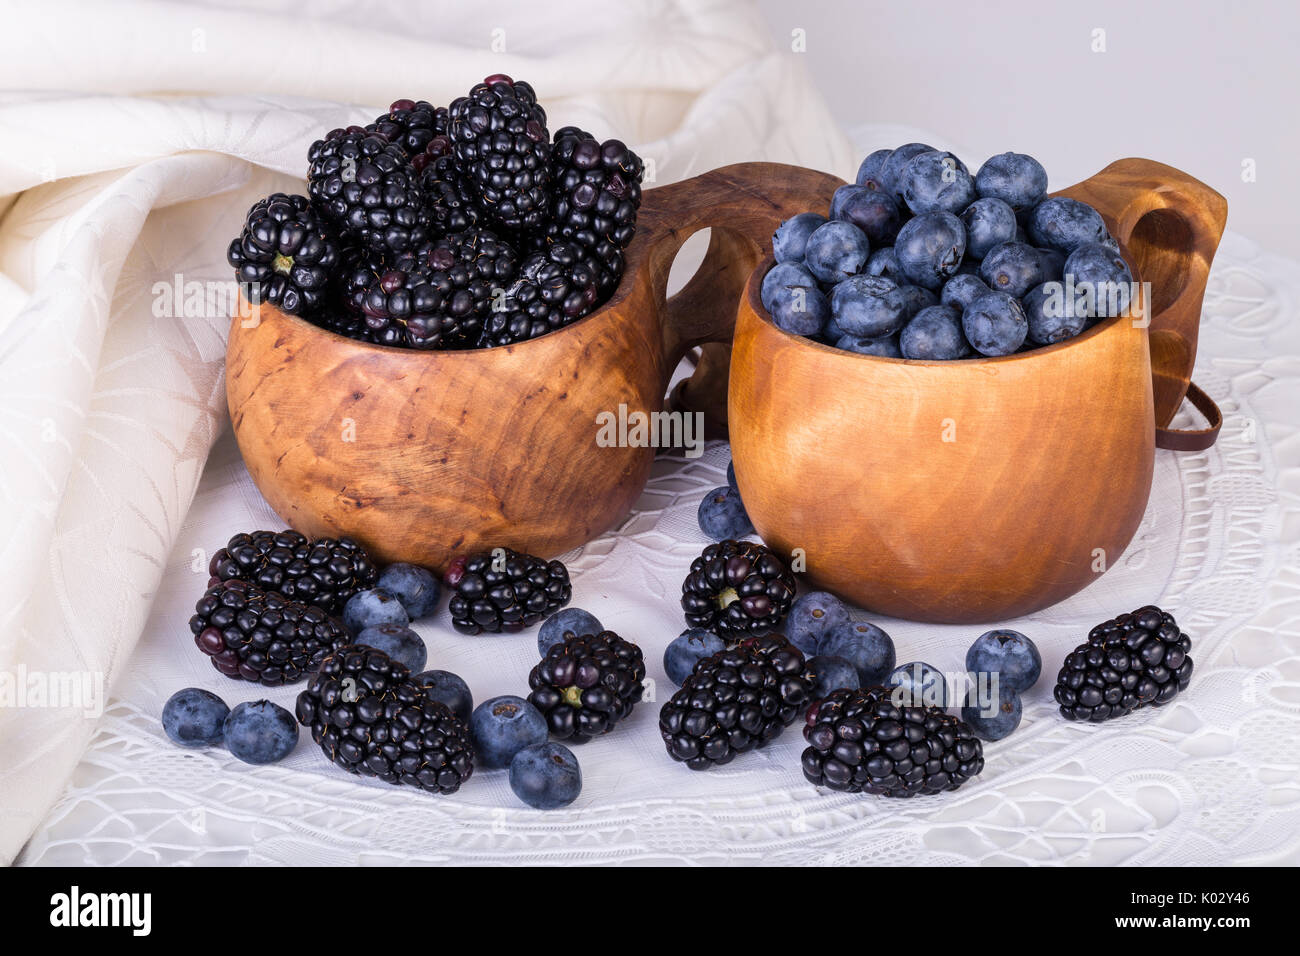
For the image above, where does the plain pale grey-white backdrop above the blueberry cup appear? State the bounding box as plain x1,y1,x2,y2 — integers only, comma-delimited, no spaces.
761,0,1300,259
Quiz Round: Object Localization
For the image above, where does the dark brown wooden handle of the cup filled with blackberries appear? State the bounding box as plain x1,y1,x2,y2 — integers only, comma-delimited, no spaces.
638,163,844,438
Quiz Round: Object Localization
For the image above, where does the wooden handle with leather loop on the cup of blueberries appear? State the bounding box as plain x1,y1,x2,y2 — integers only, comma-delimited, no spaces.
1061,159,1227,451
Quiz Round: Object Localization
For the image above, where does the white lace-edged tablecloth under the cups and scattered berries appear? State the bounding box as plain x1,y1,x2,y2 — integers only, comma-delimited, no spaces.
20,234,1300,865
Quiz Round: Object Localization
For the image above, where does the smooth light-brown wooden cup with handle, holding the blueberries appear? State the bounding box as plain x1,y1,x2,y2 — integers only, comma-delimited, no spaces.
729,159,1227,624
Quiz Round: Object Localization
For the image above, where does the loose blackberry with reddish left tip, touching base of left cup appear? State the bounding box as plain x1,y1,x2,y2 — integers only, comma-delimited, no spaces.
445,548,573,633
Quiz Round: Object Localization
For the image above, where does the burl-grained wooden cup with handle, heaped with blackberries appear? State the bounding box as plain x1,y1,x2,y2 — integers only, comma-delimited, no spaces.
226,163,839,568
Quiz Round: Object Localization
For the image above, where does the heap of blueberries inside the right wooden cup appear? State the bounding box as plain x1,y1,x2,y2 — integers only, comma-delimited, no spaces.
762,143,1132,360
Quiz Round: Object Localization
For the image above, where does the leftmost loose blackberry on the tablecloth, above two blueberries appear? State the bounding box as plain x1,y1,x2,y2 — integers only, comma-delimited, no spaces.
190,580,350,687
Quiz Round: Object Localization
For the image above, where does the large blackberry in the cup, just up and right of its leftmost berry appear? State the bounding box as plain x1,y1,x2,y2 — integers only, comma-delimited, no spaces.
307,126,428,254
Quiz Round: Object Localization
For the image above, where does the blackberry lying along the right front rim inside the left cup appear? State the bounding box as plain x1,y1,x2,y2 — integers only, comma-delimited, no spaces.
480,242,599,349
